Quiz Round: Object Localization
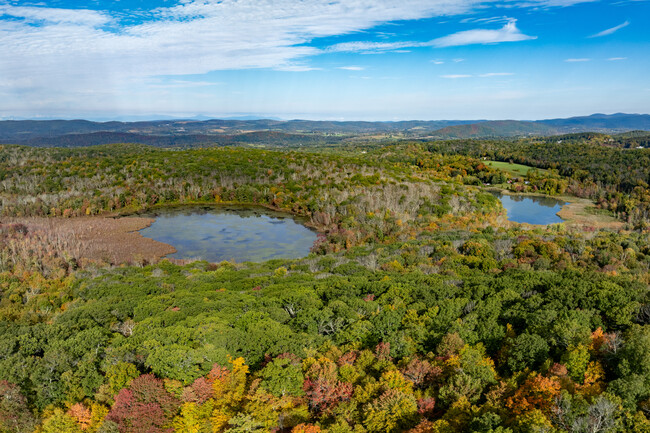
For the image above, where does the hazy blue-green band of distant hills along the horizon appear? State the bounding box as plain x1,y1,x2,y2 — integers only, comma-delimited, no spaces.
0,113,650,147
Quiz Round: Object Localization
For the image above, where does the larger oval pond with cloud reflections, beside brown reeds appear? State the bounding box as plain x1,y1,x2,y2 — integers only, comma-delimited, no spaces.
140,206,316,262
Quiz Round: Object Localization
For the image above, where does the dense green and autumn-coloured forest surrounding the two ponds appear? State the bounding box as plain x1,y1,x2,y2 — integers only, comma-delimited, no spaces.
0,139,650,433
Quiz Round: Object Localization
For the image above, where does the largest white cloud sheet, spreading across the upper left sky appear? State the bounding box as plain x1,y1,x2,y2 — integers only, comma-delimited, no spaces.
0,0,488,113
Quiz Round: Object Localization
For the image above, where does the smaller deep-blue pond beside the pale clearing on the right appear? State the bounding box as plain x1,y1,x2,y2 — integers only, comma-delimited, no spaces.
495,194,565,224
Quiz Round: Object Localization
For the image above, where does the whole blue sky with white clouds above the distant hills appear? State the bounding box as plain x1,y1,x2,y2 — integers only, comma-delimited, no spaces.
0,0,650,121
